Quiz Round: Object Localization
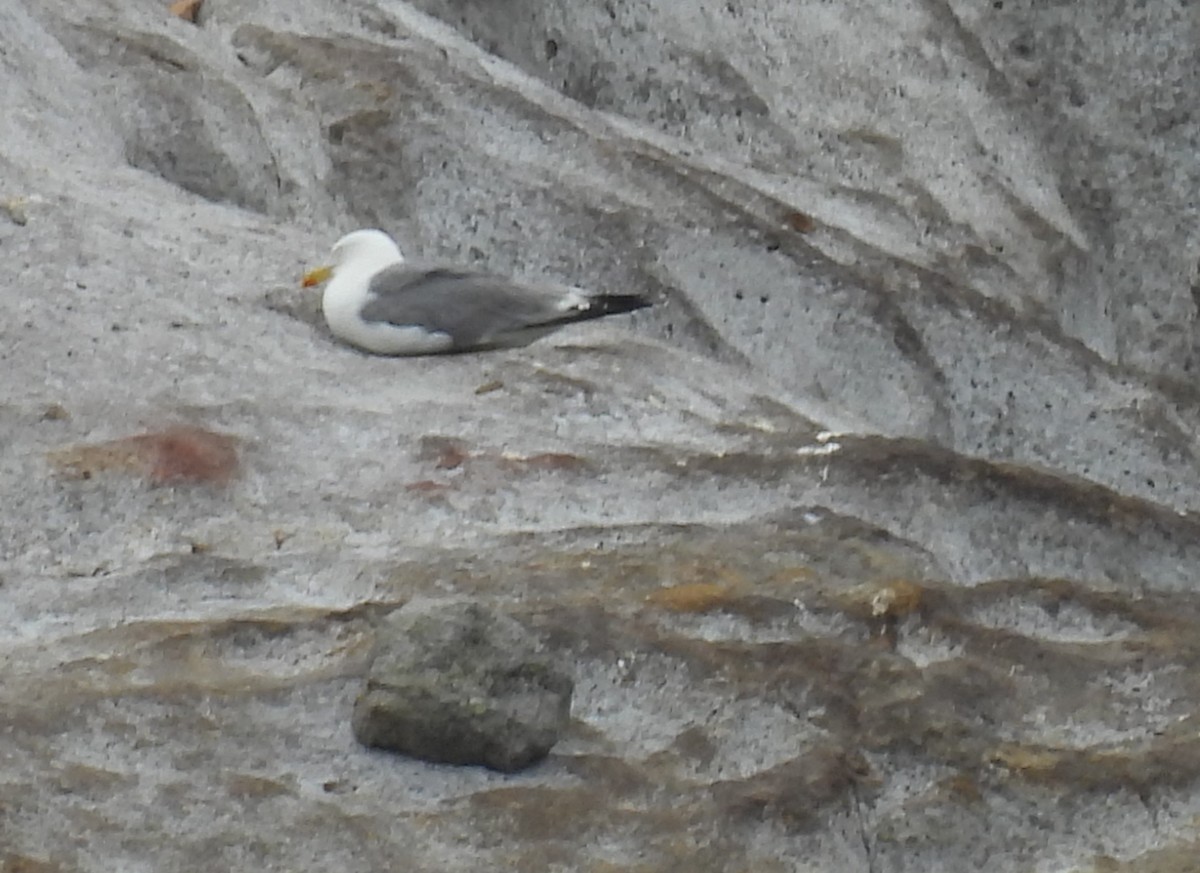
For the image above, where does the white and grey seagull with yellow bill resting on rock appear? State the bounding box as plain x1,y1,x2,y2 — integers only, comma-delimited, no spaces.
304,230,650,355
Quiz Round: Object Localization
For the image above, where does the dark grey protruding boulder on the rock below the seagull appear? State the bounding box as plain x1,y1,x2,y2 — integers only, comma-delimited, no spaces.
354,603,572,772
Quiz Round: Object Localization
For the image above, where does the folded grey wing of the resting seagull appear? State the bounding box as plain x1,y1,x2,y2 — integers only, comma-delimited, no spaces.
360,264,570,348
